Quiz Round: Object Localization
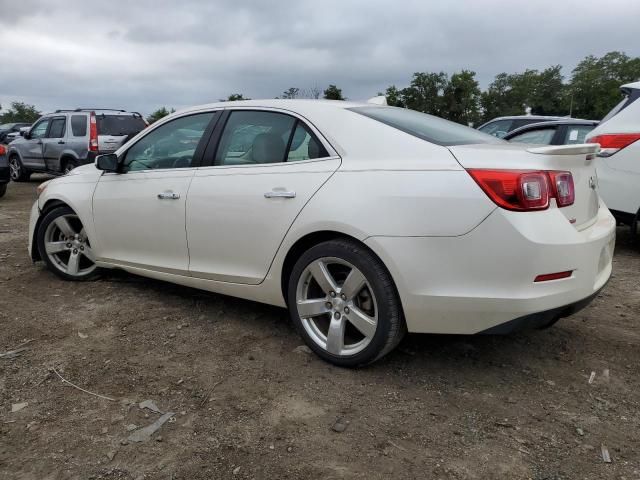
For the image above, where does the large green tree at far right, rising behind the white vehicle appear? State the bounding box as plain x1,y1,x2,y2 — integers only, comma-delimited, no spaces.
568,52,640,120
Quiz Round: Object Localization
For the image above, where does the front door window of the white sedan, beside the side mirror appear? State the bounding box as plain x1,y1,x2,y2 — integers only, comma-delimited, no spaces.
123,112,215,172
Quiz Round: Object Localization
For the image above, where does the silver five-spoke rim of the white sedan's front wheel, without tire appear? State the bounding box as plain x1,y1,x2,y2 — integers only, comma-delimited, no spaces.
44,214,96,277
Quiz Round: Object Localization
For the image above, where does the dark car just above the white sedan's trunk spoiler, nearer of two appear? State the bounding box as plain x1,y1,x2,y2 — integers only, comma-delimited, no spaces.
503,118,599,145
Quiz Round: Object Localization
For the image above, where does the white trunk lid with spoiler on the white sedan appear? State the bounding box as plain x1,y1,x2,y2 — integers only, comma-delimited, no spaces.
448,143,600,230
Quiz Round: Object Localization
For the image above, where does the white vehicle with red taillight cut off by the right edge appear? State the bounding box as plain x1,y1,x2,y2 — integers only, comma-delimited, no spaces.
587,82,640,242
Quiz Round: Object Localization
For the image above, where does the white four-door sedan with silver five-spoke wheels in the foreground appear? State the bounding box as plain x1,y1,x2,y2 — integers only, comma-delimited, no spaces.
29,100,615,366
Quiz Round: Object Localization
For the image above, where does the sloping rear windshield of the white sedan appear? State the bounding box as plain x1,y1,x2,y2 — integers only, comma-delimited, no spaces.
349,107,504,146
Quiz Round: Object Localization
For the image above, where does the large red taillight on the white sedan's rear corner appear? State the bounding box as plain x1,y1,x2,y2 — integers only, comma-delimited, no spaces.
467,169,575,212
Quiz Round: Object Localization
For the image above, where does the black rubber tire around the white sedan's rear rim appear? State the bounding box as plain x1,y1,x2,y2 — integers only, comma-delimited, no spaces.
287,239,406,367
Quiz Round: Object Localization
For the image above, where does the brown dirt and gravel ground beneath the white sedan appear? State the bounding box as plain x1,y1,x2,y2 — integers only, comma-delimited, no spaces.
0,179,640,480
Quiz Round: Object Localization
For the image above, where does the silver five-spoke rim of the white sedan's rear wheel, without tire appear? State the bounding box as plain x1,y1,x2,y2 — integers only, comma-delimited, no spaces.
296,257,378,356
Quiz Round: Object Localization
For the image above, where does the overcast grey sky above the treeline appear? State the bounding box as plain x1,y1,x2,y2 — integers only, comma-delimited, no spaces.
0,0,640,114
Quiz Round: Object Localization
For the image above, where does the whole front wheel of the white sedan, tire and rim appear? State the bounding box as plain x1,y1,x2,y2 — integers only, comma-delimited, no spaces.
36,207,97,280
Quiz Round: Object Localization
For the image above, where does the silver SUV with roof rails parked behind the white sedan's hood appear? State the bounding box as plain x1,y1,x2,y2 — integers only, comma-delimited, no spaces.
8,108,147,182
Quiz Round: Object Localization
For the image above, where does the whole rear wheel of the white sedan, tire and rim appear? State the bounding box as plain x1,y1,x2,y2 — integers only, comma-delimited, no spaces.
288,239,406,367
